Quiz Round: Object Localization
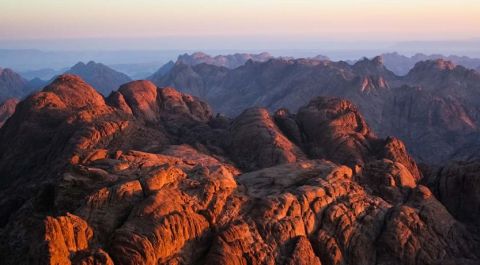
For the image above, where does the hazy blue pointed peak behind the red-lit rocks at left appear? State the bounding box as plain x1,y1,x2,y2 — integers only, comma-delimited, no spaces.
65,61,131,96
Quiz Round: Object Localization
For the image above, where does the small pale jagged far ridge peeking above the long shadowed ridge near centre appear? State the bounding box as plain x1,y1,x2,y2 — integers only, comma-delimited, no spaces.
177,52,273,69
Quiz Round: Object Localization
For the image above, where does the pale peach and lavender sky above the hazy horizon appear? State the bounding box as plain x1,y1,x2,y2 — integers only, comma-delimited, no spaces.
0,0,480,53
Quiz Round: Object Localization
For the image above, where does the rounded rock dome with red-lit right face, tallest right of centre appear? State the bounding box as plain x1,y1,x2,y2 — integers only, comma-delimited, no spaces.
297,98,374,165
